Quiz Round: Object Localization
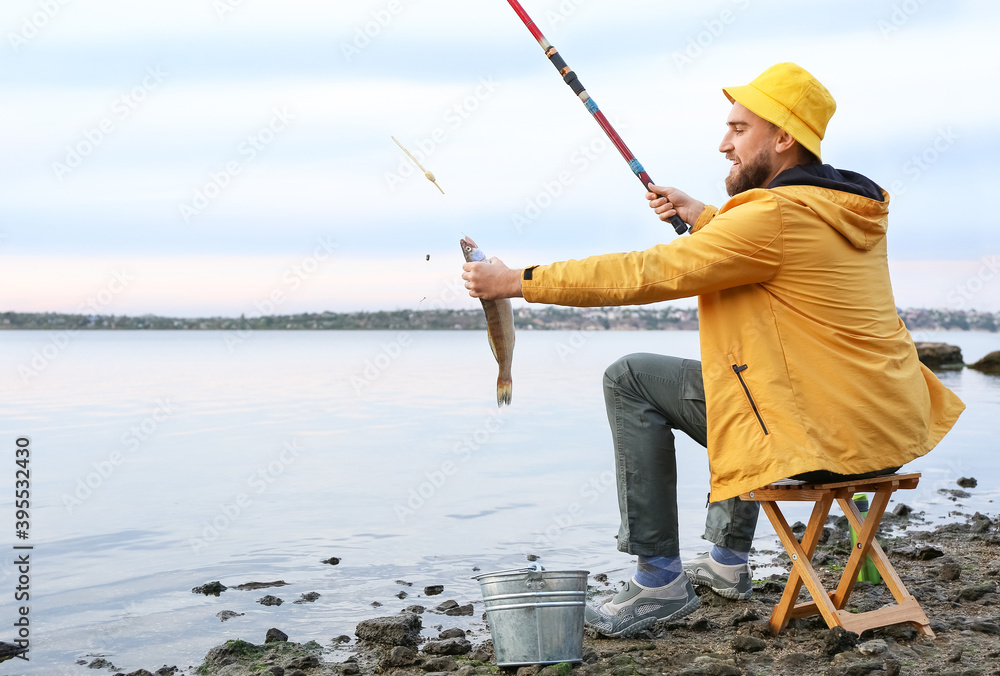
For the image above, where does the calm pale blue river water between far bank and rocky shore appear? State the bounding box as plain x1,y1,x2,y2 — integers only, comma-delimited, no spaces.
0,331,1000,674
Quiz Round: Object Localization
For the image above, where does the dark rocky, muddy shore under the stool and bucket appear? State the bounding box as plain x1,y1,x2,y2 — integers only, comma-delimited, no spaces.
87,492,1000,676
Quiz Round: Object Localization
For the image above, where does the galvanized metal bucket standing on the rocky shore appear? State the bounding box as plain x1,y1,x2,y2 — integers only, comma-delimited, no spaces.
473,566,590,667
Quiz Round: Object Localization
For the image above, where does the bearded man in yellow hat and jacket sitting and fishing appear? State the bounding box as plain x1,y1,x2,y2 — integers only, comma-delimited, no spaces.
462,63,964,636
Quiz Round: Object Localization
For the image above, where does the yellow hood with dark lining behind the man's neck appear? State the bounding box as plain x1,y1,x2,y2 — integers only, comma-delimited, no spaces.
767,164,889,251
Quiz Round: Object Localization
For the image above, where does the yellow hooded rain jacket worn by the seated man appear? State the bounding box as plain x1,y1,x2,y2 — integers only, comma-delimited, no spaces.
522,165,965,501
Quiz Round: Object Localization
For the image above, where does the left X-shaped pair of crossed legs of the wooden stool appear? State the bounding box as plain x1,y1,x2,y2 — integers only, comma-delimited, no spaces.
761,492,837,634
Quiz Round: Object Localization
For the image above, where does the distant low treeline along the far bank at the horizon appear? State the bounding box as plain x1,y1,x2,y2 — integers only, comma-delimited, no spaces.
0,306,1000,332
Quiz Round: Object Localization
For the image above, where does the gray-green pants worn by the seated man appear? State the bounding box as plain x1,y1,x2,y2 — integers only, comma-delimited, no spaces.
604,353,760,556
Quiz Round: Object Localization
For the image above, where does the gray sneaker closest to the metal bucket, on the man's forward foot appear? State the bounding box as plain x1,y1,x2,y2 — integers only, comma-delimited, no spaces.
583,575,701,636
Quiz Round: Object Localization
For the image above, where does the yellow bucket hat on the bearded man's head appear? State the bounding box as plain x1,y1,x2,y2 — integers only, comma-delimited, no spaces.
722,63,837,164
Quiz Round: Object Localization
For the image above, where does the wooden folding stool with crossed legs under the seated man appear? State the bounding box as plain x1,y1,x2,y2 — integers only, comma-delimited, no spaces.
740,474,934,636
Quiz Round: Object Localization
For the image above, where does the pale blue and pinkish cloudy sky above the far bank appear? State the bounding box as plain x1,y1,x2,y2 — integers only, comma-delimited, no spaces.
0,0,1000,316
